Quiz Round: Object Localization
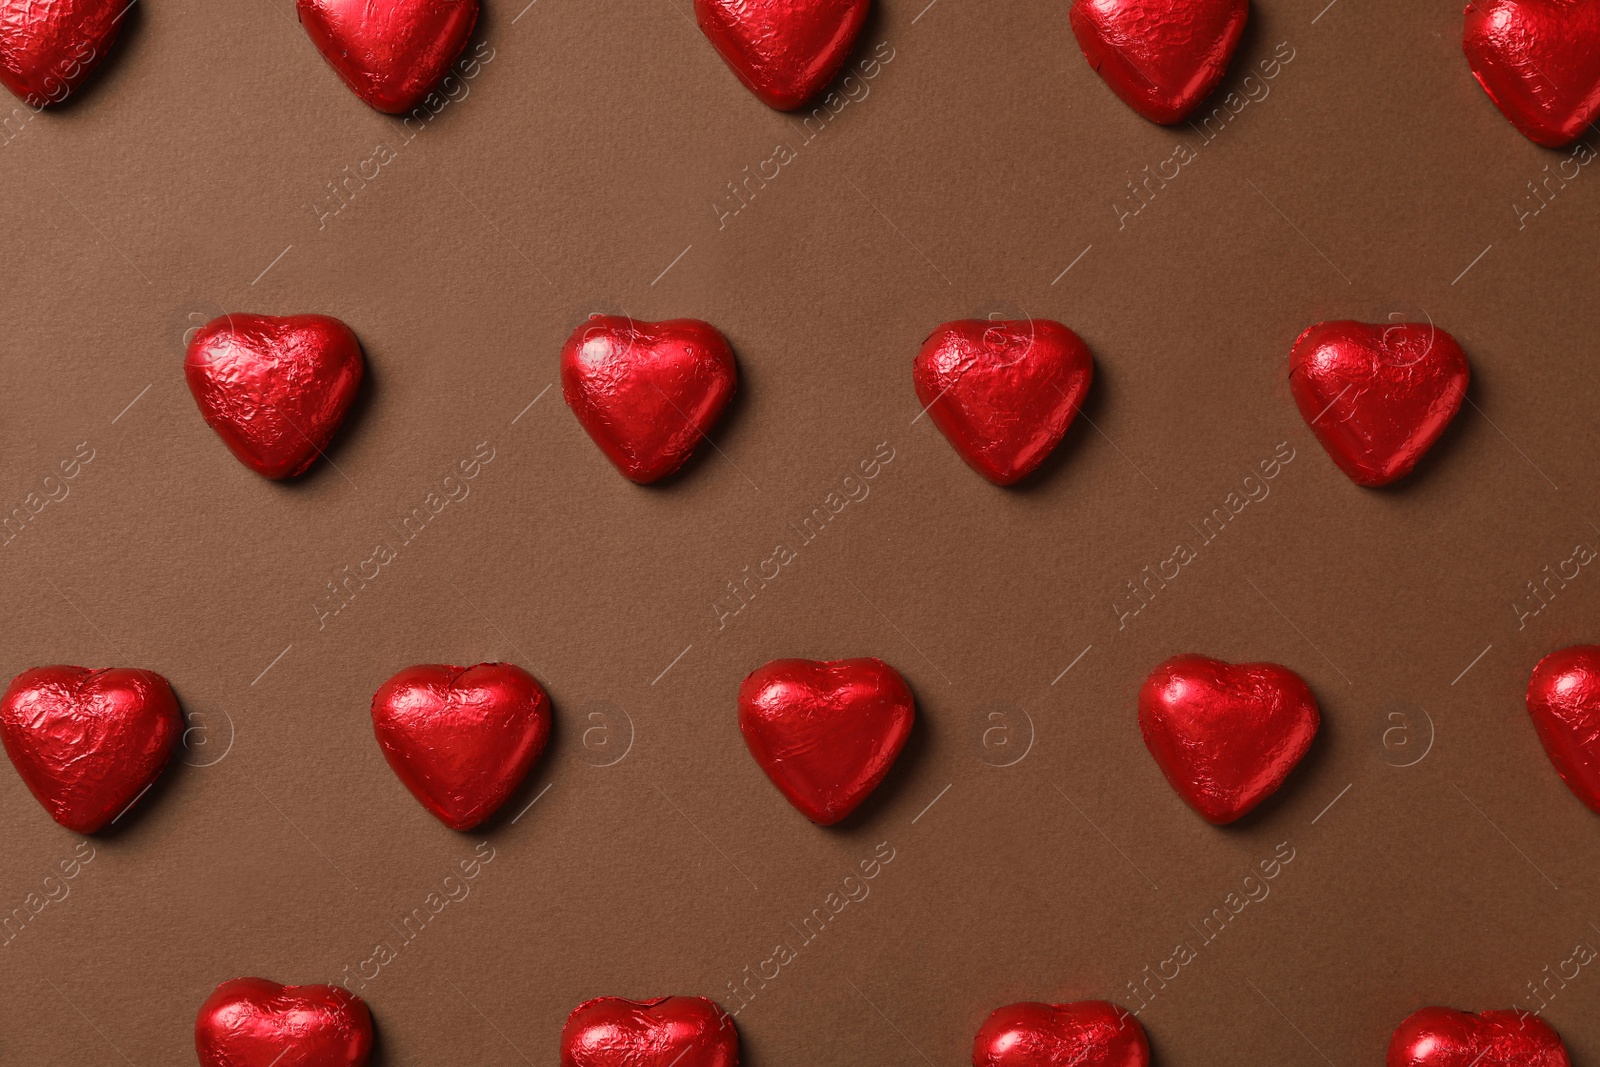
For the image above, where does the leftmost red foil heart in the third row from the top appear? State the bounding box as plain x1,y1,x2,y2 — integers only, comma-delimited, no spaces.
0,667,182,833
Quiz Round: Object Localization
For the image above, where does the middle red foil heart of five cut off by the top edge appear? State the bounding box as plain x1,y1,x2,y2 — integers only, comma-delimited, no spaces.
694,0,869,110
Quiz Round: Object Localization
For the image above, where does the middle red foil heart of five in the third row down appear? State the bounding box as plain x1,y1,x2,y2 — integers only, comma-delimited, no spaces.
739,659,915,825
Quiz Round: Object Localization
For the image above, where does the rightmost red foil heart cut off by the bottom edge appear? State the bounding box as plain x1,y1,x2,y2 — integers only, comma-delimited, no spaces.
1384,1008,1571,1067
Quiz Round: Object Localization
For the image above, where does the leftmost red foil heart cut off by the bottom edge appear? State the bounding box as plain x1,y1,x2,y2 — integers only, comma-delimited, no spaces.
195,977,373,1067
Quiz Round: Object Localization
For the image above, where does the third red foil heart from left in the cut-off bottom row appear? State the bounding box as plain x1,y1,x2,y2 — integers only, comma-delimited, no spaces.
973,1000,1150,1067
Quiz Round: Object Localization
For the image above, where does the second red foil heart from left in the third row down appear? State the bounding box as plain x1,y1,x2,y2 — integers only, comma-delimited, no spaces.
373,664,550,830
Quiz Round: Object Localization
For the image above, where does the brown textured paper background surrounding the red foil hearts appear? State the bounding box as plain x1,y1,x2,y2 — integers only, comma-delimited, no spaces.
0,0,1600,1067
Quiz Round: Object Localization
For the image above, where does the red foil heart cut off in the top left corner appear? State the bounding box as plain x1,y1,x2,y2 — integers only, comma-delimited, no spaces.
0,0,128,107
